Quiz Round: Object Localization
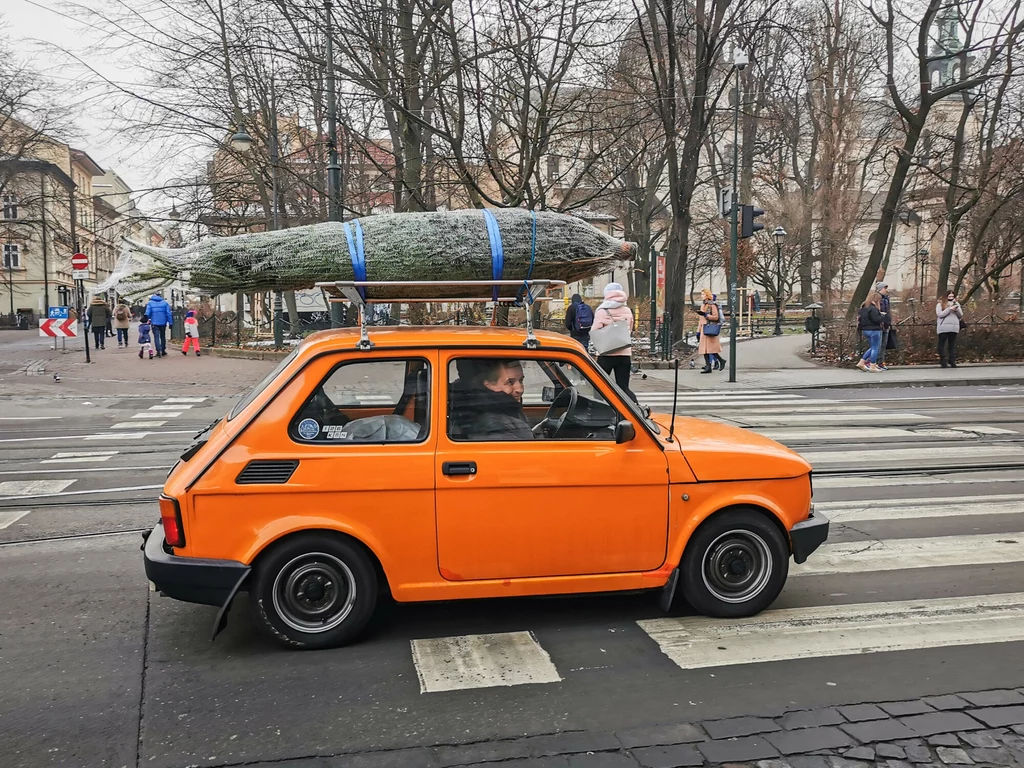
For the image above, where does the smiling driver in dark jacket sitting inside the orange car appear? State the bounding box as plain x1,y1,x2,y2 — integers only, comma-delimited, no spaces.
453,357,535,440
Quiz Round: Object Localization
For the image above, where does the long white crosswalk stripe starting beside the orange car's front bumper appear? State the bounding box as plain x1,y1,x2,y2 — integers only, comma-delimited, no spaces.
790,531,1024,577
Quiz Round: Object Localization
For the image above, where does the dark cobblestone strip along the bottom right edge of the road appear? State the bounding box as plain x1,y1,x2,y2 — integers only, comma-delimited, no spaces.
235,689,1024,768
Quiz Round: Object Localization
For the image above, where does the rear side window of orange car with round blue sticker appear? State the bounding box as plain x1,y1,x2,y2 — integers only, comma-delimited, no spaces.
288,357,430,443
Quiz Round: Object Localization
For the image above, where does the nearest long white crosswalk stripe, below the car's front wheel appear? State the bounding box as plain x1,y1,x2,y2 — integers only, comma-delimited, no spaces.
637,593,1024,670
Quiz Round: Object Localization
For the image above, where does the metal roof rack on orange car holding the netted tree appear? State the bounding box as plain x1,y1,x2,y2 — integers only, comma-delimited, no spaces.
316,280,565,350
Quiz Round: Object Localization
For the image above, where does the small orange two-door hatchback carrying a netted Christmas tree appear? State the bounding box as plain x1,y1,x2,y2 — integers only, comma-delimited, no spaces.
143,327,828,648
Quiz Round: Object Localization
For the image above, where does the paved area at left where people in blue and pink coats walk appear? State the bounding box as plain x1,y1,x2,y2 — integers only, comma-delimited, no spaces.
0,331,278,397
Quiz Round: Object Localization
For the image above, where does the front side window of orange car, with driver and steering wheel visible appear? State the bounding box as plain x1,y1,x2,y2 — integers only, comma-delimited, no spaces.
446,357,620,441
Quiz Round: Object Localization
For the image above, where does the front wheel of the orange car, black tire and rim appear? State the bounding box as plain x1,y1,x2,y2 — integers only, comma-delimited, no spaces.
680,509,790,618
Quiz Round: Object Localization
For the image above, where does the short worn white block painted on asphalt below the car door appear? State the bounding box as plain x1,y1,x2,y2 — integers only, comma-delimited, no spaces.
412,632,562,693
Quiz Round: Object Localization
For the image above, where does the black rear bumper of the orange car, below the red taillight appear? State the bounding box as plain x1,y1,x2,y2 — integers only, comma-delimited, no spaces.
142,523,250,607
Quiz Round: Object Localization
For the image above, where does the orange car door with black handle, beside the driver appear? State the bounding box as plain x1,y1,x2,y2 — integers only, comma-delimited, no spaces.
434,351,669,581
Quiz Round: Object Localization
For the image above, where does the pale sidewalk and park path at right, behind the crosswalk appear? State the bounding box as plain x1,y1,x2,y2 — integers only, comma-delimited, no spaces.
644,334,1024,390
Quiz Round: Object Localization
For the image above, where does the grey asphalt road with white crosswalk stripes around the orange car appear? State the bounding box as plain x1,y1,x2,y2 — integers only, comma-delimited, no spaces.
0,387,1024,768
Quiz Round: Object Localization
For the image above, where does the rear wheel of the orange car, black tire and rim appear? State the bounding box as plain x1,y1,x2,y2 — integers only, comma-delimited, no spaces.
249,534,378,650
